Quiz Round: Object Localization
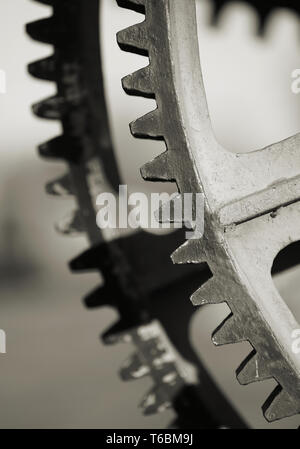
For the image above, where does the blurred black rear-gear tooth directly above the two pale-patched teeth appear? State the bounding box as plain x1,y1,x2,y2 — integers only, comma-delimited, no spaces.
38,136,81,162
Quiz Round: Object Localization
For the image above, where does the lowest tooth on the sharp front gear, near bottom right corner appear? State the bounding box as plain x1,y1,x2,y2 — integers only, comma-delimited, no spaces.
263,385,300,422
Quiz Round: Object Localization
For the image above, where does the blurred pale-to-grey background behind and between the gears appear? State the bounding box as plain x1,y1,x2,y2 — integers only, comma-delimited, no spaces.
0,0,300,428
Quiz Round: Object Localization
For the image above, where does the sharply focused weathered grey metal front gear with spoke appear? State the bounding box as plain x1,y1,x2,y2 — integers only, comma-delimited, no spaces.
118,0,300,421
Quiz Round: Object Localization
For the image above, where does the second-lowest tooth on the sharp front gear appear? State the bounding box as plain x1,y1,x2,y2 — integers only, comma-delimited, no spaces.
237,350,271,385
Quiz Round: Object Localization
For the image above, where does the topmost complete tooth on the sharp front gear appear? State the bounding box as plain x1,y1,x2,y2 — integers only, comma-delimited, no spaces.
117,21,149,56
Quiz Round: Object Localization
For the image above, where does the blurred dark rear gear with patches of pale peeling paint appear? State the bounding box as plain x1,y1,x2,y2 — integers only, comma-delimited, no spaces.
27,0,245,428
